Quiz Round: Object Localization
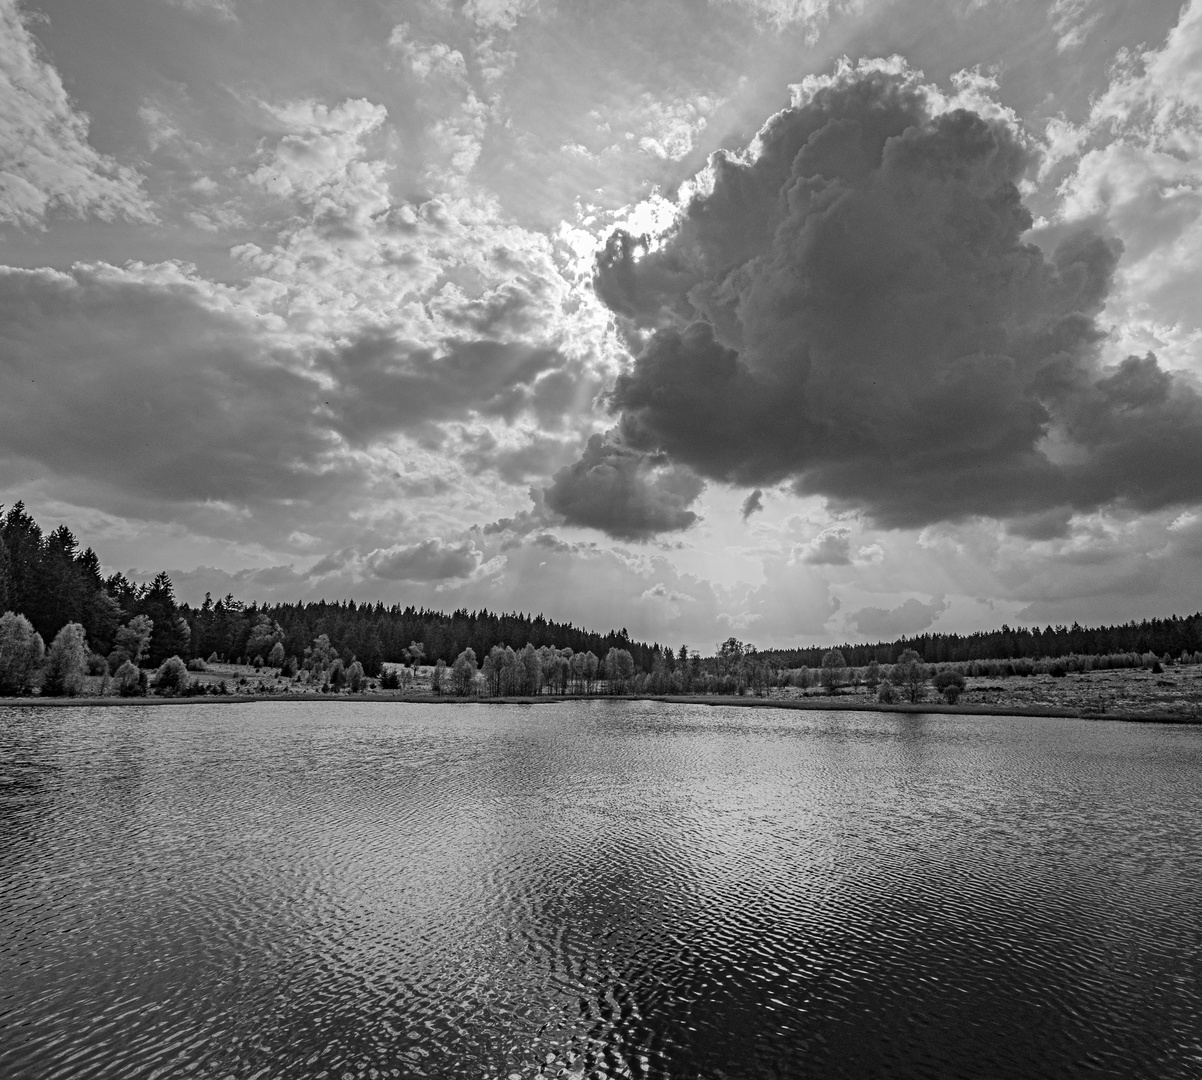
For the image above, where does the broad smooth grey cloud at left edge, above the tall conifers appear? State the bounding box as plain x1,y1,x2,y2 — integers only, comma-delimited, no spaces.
0,267,355,514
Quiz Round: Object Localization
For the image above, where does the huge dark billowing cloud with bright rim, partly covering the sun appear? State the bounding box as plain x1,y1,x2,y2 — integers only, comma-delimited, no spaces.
569,70,1202,529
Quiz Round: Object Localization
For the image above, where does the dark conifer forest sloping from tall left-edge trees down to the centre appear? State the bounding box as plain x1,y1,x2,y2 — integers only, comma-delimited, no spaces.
0,502,664,686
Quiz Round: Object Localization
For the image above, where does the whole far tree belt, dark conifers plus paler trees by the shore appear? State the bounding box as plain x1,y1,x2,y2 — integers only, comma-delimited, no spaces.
0,502,1202,694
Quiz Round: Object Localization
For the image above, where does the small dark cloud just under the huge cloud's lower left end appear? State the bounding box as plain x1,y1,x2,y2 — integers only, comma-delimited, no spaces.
545,435,704,539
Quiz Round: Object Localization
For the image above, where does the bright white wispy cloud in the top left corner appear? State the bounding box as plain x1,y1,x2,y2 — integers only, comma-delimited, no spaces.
0,0,155,228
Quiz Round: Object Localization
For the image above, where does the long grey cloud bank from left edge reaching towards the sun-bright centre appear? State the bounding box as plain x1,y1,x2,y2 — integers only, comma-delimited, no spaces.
0,265,586,530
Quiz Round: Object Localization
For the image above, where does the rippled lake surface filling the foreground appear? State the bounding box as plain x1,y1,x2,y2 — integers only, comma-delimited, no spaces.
0,702,1202,1080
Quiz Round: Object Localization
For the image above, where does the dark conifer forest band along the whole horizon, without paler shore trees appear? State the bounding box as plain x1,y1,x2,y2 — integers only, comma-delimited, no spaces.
0,502,1202,691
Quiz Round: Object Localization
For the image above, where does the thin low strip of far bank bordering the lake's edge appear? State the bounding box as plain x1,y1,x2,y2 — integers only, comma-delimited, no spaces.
0,692,1202,726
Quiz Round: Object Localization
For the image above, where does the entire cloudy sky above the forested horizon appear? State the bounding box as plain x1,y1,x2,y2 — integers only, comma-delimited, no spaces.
0,0,1202,651
